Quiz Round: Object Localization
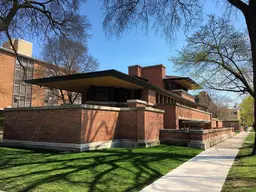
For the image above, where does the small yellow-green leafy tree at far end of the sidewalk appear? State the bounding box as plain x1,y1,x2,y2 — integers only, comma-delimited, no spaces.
239,96,254,126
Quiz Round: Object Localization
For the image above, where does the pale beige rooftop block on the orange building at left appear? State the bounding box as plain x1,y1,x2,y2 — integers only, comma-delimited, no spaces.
3,39,33,57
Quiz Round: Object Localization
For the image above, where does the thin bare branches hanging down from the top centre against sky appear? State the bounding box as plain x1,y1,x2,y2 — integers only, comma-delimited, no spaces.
103,0,203,39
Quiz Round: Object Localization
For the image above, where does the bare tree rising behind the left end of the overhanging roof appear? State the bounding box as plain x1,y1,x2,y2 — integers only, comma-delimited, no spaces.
42,37,99,104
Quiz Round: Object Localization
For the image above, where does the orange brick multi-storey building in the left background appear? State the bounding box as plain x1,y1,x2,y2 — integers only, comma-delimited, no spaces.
0,39,79,109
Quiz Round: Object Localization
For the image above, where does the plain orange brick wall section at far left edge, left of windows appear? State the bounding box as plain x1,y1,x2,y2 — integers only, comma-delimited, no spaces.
0,52,16,108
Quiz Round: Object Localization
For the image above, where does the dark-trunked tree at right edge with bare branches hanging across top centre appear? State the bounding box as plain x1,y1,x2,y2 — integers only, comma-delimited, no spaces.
103,0,256,155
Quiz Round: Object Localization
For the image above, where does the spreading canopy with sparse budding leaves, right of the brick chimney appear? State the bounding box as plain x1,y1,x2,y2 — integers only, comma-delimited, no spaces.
170,15,254,96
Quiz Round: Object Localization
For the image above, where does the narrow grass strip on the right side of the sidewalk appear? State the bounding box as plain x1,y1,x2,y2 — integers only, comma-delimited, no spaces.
222,132,256,192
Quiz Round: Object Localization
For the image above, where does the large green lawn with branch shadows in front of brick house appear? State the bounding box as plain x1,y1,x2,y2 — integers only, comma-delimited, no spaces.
0,145,202,192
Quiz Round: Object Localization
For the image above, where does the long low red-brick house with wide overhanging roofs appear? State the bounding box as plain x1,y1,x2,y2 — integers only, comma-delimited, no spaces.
3,39,236,151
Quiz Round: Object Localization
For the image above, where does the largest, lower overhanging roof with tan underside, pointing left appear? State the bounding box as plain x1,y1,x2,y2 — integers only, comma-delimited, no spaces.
25,69,197,106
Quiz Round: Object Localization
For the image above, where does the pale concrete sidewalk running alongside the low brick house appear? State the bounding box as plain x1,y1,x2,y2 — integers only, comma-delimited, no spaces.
141,132,248,192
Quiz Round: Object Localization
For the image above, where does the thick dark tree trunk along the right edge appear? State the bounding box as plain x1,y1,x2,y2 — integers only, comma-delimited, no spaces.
244,13,256,155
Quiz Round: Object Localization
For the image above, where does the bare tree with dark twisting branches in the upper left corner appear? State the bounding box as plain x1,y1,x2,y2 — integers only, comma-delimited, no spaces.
0,0,90,68
